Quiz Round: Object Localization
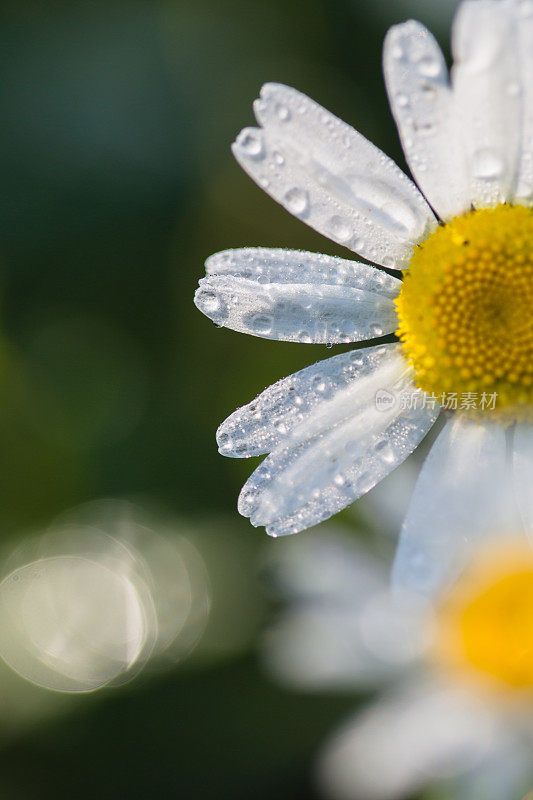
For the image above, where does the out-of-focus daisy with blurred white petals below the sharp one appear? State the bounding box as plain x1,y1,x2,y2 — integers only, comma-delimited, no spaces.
263,530,533,800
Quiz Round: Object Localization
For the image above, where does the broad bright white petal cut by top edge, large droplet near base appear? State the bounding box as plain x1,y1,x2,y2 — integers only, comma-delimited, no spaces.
452,0,521,207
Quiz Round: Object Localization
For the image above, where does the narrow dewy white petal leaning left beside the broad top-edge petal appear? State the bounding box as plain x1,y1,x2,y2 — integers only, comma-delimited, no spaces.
383,20,471,220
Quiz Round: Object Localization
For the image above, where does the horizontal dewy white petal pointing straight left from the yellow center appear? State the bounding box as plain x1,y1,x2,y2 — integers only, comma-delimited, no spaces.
195,248,401,344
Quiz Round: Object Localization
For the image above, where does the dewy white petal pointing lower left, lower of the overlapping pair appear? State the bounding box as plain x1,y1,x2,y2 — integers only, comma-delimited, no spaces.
239,353,438,536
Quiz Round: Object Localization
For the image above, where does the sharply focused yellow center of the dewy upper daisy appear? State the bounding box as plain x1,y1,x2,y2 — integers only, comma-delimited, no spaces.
396,205,533,419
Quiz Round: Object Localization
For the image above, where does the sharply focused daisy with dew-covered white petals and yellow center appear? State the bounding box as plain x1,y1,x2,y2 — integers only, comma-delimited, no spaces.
195,0,533,544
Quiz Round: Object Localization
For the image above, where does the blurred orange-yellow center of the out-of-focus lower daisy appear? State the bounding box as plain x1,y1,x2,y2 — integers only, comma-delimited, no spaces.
436,549,533,690
